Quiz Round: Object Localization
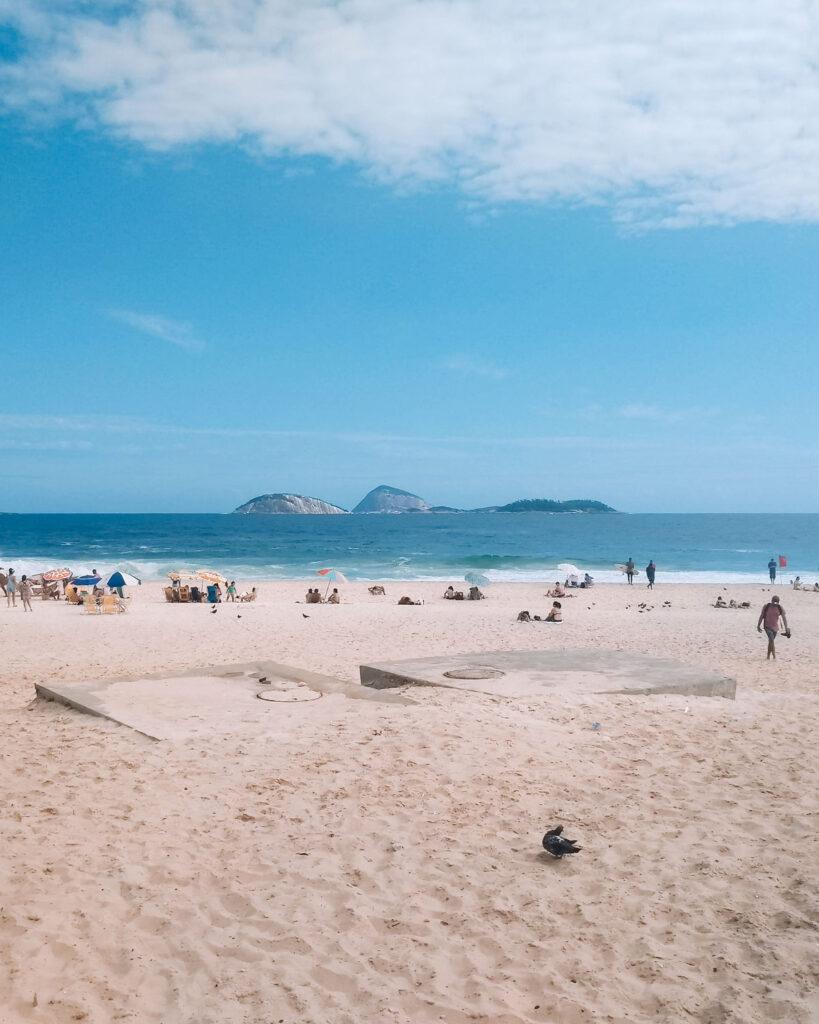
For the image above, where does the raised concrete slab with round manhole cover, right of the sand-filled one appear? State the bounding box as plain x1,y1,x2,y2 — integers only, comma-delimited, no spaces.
360,649,736,699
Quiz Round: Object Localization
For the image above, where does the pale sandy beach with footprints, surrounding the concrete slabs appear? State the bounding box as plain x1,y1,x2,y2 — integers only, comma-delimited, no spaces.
0,582,819,1024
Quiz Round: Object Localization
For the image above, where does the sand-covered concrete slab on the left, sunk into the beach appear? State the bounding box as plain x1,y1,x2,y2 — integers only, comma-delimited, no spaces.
35,662,412,740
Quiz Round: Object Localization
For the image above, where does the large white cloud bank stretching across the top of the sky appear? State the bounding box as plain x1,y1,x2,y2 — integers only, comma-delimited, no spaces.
0,0,819,225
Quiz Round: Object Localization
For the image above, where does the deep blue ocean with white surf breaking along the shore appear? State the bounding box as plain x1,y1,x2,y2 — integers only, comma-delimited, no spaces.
0,512,819,583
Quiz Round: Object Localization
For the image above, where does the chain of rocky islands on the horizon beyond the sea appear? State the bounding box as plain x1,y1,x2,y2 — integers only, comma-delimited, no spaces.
232,483,617,515
